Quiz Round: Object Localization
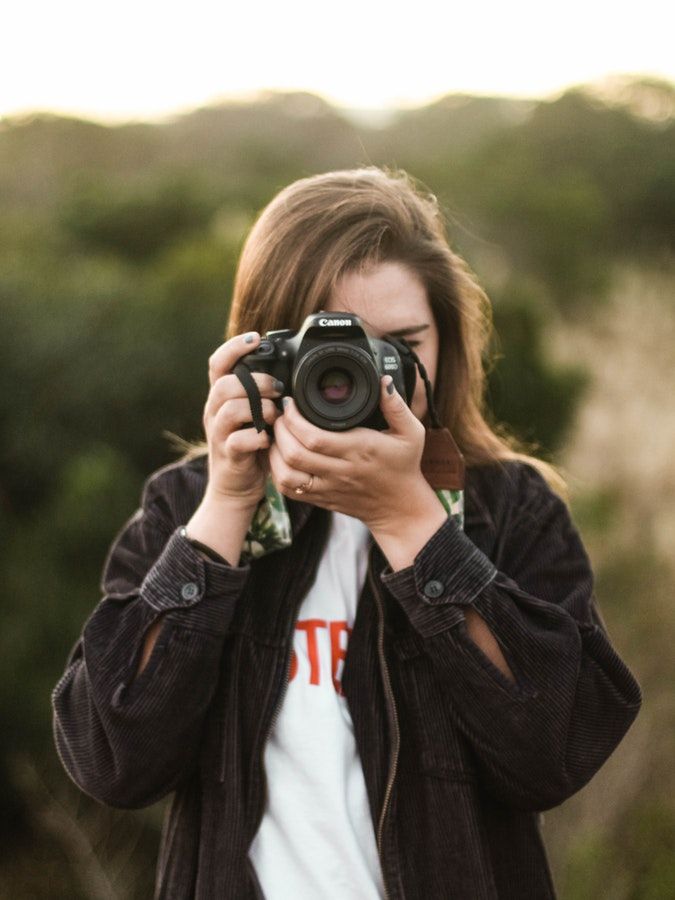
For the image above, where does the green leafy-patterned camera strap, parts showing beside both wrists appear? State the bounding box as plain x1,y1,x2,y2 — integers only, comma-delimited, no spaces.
241,476,464,562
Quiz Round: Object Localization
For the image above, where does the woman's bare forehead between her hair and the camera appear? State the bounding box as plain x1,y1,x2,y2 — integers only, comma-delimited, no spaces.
326,262,432,331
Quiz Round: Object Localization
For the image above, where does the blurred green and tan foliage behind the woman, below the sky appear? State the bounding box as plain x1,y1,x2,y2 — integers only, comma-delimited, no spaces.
0,79,675,900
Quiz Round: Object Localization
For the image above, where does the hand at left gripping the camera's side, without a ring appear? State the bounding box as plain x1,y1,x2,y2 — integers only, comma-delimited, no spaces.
203,331,284,509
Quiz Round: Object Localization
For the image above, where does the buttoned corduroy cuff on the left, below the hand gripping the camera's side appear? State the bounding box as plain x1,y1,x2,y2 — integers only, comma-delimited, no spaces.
141,528,251,635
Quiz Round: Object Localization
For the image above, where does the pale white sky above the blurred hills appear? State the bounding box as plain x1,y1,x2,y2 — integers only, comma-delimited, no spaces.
0,0,675,121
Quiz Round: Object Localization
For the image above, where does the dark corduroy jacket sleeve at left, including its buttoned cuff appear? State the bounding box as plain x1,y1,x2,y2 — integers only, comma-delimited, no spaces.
52,473,250,807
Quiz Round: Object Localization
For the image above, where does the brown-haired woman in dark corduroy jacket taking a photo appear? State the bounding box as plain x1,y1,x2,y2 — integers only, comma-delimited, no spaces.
54,169,640,900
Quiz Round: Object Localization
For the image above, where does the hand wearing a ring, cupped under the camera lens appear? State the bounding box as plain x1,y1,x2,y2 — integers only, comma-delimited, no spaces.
269,376,434,531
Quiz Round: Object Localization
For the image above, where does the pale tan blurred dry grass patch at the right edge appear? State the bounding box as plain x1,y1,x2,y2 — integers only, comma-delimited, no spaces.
553,260,675,557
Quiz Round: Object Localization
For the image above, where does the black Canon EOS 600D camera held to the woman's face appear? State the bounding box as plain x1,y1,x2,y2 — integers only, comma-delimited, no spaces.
241,312,416,431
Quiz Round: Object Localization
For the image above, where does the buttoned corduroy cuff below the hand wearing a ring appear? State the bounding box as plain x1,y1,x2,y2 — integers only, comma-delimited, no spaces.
380,517,497,634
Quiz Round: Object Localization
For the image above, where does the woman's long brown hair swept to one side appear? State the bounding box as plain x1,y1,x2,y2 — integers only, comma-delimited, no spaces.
226,167,566,496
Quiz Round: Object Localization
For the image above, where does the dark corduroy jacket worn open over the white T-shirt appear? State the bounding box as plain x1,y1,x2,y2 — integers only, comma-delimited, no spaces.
53,459,640,900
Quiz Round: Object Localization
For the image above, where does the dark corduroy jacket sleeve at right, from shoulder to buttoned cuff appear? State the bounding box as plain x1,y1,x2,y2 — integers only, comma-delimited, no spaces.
380,466,641,810
